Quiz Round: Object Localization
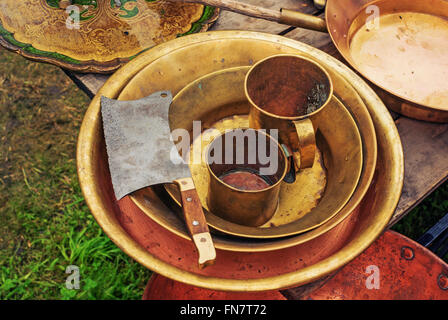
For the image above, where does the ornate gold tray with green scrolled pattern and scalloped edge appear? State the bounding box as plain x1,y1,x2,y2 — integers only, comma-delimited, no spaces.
0,0,219,73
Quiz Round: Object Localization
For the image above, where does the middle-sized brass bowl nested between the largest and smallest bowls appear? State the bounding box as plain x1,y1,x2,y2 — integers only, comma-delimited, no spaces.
118,31,377,252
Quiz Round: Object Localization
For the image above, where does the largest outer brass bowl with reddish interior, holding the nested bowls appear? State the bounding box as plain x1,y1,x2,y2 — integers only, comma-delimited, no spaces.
77,31,404,291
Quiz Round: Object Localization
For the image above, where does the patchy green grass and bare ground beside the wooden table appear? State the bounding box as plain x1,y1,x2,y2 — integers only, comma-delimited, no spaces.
0,45,448,299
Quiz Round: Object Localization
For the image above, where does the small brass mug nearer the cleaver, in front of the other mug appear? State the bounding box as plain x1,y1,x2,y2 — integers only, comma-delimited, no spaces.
206,129,287,227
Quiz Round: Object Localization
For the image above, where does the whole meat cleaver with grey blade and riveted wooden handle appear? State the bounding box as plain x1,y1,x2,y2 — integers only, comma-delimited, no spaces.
101,91,216,268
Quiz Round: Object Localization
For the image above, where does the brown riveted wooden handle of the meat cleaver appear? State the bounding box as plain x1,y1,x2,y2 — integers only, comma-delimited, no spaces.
174,178,216,268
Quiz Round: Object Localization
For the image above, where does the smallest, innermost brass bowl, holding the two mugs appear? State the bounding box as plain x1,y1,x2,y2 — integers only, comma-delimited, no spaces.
133,66,362,239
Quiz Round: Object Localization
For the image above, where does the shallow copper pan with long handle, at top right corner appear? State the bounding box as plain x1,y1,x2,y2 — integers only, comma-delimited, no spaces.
178,0,448,123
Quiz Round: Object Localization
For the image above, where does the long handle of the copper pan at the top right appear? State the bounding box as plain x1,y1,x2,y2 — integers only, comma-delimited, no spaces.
172,0,327,32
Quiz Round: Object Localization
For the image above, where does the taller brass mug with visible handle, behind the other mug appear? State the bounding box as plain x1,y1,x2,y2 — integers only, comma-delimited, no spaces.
244,55,333,171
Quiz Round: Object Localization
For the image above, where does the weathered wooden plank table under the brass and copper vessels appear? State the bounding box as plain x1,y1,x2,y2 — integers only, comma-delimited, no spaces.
66,0,448,298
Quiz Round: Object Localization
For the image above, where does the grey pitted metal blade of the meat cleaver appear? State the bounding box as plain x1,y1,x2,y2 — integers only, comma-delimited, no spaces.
101,91,191,200
